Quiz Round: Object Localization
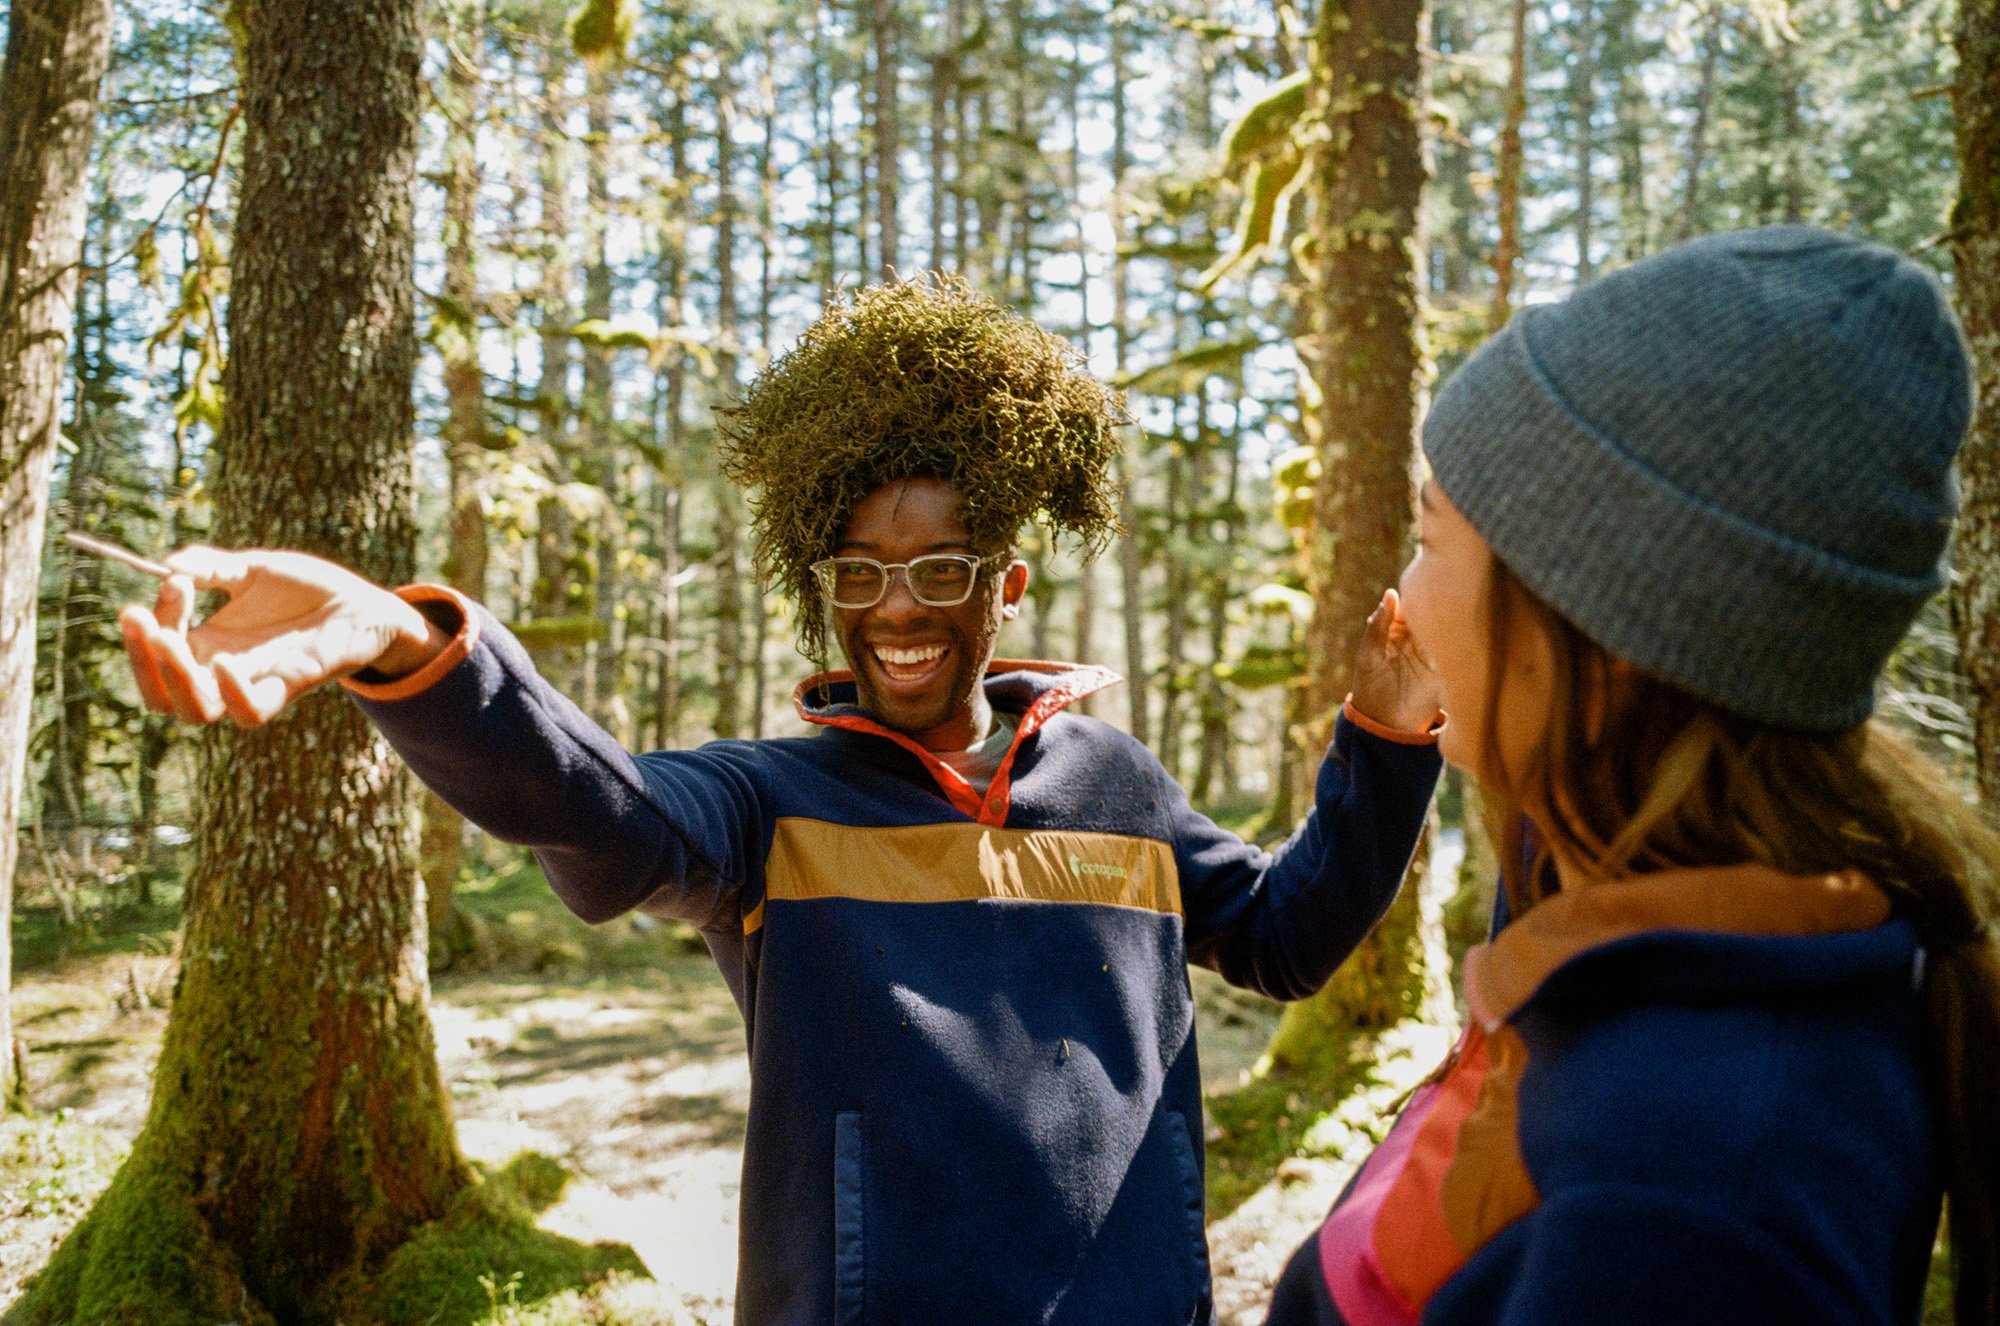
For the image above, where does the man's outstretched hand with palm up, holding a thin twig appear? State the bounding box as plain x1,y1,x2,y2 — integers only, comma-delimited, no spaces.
118,546,446,728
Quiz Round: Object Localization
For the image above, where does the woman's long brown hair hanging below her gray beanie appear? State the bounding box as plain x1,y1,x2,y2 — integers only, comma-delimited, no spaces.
1480,560,2000,1326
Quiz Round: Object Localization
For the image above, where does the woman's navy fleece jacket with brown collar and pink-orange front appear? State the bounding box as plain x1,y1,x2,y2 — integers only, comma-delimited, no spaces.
1268,866,1940,1326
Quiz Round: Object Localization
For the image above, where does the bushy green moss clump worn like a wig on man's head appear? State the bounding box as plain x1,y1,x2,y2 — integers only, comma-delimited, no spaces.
722,276,1124,662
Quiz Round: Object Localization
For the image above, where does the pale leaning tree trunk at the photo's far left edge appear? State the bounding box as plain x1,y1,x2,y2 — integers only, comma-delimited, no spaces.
0,0,112,1106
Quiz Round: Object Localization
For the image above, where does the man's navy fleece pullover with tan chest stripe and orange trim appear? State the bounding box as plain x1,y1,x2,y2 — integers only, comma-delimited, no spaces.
350,586,1438,1326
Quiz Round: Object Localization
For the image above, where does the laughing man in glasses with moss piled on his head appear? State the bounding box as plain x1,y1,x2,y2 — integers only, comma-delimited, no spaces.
124,280,1438,1326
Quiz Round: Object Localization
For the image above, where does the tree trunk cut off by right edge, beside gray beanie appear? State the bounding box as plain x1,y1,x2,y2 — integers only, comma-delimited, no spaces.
1952,0,2000,810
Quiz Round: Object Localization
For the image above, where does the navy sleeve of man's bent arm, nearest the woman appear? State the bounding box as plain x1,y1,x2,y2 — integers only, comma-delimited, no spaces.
1168,706,1442,1000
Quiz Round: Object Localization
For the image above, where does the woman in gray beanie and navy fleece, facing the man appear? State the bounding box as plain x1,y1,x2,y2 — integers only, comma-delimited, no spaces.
1270,228,2000,1326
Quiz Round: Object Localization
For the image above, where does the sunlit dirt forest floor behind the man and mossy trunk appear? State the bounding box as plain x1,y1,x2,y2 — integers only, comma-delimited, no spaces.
0,954,1324,1322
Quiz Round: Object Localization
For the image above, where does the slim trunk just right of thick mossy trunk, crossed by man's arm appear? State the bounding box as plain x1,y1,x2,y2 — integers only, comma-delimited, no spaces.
420,0,488,956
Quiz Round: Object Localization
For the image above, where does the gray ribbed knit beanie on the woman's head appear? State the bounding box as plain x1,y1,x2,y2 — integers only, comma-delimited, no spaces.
1424,226,1972,732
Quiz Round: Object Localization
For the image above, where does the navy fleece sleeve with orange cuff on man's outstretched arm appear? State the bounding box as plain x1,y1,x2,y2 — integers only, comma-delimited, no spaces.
346,586,768,928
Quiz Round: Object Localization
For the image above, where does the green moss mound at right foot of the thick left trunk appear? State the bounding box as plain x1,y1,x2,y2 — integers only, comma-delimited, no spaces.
356,1154,646,1326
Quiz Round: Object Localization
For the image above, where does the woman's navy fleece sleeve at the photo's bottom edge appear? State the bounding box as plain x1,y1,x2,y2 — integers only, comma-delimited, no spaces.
1424,1184,1878,1326
